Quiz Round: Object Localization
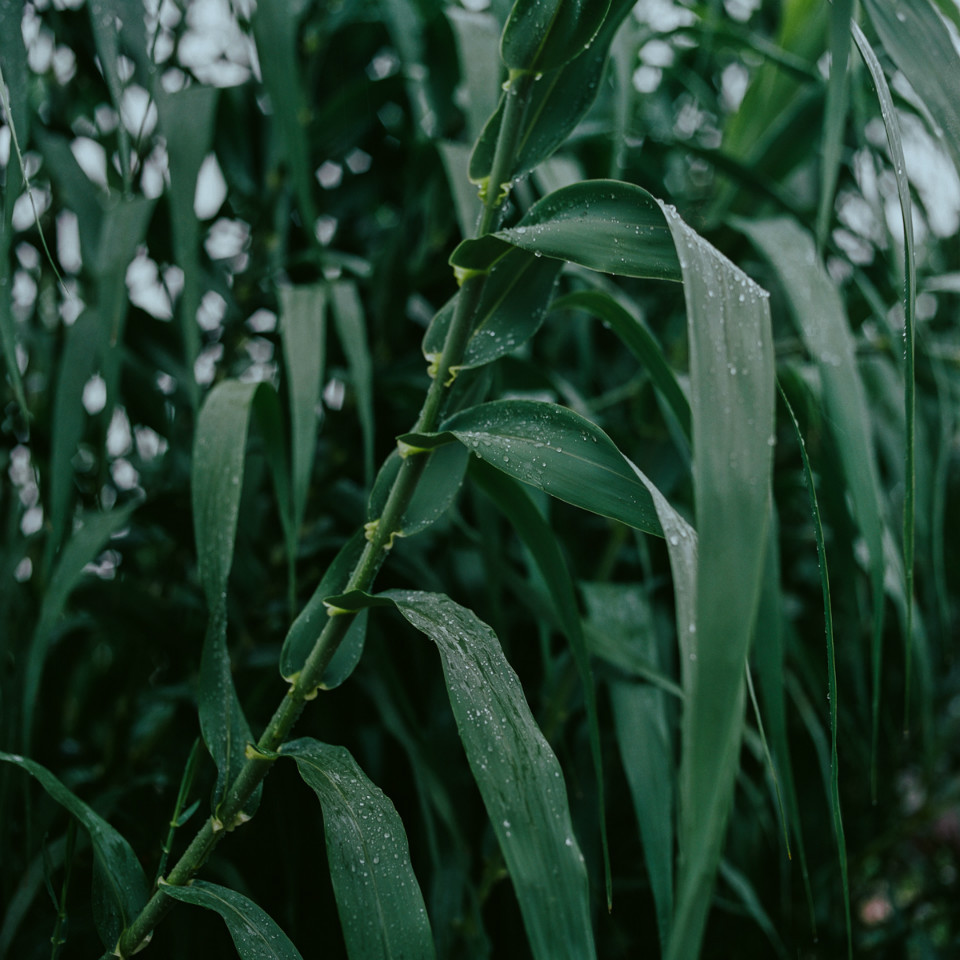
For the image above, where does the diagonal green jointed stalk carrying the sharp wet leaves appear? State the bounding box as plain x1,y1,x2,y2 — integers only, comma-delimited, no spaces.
115,71,533,957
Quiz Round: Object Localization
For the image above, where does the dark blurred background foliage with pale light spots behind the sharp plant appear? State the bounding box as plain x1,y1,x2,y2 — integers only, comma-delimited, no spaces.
0,0,960,958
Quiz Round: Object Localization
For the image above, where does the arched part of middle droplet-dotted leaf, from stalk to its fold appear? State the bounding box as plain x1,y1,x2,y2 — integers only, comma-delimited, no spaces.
400,400,662,536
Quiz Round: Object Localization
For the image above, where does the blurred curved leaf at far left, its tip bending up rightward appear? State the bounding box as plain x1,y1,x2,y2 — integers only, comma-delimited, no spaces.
21,503,138,750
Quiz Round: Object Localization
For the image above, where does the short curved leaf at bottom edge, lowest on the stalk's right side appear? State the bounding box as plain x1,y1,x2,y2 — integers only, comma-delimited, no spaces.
160,880,302,960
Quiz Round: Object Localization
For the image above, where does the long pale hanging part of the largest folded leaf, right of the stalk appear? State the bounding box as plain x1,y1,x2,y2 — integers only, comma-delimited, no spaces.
654,207,774,960
